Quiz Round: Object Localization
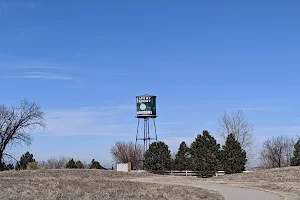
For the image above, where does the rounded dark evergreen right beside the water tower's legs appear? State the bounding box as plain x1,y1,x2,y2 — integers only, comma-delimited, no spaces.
145,141,171,172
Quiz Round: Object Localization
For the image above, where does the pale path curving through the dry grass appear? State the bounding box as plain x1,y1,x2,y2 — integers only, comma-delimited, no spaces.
129,177,282,200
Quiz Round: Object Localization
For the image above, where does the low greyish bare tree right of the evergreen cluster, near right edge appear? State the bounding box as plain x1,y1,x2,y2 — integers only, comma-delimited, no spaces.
260,136,294,168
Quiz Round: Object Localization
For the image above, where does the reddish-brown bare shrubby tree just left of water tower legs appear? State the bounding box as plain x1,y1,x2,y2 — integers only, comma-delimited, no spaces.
110,141,143,169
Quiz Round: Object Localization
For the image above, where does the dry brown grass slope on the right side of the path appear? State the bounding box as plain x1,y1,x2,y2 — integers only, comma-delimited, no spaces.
157,167,300,200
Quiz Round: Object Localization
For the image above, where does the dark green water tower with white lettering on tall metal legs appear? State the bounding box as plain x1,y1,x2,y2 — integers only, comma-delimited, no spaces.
136,94,157,151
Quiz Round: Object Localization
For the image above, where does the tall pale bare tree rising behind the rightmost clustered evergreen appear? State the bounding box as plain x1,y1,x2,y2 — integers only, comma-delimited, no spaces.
218,109,255,160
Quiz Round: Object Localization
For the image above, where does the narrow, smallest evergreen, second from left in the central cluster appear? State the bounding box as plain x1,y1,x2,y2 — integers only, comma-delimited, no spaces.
175,142,191,171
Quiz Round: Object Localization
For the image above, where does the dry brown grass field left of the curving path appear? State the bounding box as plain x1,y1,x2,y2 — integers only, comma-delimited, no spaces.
0,170,223,200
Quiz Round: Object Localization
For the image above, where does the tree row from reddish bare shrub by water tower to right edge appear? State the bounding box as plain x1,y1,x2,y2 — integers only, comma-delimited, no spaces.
110,110,300,176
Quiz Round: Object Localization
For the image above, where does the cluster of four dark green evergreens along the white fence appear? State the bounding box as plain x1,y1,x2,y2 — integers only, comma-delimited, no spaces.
145,130,247,177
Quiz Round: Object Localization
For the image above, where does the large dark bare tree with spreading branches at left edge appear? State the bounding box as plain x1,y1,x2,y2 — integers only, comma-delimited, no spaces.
0,99,45,168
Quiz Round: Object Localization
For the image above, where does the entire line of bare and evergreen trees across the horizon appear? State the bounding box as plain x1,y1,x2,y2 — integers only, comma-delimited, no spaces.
0,99,300,175
